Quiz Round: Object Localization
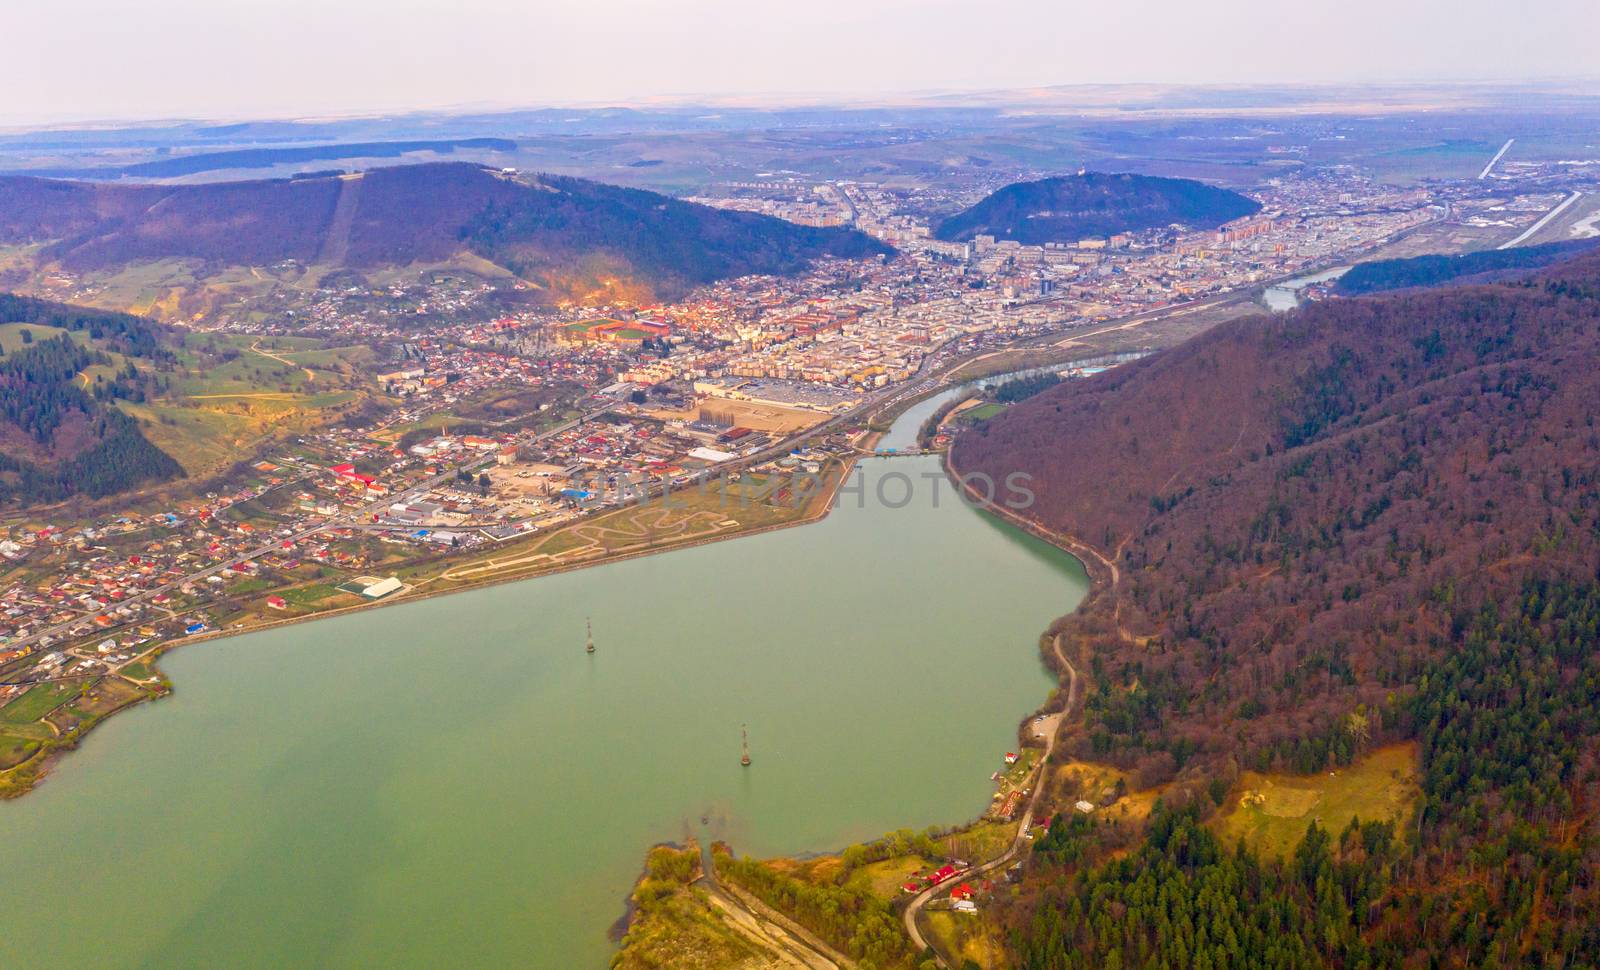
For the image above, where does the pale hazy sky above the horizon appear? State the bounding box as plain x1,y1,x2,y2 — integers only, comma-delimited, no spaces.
0,0,1600,122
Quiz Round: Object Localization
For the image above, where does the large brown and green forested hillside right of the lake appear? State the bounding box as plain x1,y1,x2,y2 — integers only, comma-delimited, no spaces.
952,256,1600,967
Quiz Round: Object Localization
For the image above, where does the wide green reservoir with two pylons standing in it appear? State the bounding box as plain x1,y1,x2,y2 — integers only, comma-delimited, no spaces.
0,403,1086,968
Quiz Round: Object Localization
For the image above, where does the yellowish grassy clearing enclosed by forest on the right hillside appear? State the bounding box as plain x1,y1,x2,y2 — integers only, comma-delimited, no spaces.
1213,744,1418,856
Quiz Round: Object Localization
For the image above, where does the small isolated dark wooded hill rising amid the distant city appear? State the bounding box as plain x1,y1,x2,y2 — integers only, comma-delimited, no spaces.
934,171,1261,245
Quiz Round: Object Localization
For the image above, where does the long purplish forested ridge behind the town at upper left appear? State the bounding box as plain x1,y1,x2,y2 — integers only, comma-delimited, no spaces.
0,163,890,296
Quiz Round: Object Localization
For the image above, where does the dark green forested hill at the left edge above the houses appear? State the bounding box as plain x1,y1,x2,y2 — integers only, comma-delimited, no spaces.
0,295,182,506
